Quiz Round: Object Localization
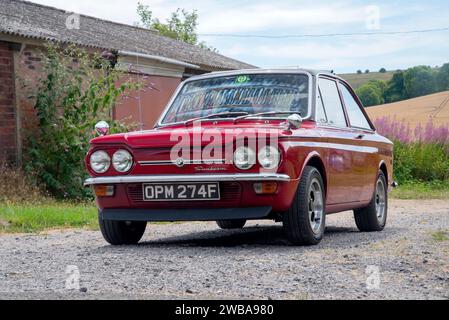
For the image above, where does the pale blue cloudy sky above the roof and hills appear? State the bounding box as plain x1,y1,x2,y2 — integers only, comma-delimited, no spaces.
32,0,449,73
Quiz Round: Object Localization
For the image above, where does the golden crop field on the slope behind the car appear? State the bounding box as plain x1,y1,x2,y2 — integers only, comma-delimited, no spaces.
366,91,449,127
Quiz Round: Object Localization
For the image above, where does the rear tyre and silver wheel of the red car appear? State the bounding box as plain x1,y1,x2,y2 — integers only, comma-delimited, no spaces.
354,171,388,232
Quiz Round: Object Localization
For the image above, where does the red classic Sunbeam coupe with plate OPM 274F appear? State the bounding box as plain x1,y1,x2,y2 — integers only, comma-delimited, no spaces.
85,69,394,245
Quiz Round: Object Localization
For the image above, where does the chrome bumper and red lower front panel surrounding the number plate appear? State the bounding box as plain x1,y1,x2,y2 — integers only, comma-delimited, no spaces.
85,173,299,214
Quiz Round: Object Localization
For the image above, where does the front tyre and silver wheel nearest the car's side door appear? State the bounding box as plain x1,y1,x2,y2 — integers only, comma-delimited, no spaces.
283,166,326,246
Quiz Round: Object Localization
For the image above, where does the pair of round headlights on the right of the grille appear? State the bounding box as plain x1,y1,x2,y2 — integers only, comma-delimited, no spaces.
234,146,281,170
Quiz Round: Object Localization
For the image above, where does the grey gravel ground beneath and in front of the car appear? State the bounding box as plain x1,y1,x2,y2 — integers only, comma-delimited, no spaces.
0,200,449,299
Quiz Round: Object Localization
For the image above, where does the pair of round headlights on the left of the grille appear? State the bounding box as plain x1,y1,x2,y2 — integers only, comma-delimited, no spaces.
90,150,133,173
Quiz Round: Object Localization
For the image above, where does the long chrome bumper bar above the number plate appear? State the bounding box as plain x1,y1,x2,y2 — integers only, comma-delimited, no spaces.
84,173,291,186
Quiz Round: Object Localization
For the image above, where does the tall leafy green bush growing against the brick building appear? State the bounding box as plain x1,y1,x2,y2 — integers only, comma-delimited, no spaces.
24,44,144,199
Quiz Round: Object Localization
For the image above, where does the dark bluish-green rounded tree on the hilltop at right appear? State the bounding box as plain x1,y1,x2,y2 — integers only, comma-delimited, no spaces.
404,66,437,98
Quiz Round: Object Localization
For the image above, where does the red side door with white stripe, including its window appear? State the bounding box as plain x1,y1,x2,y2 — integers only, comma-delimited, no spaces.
317,77,365,205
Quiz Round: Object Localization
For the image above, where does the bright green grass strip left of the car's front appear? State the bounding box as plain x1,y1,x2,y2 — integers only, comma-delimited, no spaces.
0,202,98,233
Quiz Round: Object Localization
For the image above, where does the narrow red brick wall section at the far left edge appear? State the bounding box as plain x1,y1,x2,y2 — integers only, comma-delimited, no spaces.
0,41,17,162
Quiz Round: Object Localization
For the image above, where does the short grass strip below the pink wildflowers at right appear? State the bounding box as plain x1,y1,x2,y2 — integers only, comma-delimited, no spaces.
390,181,449,200
